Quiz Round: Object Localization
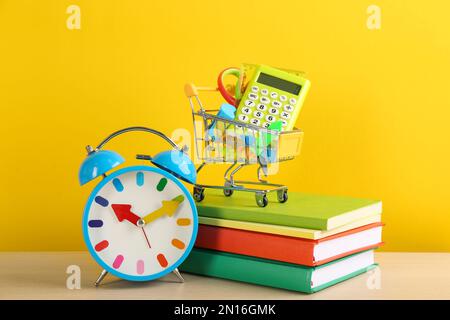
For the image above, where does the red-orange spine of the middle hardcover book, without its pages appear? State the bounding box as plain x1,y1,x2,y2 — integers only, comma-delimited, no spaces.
195,225,315,266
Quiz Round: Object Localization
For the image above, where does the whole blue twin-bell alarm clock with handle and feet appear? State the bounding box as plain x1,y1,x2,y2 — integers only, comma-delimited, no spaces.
79,127,198,285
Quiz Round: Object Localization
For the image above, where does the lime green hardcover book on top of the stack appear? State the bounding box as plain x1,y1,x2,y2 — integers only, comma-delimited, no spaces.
197,189,382,230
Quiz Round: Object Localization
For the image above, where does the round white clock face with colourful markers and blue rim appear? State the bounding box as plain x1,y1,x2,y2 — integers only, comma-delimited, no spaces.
83,166,198,281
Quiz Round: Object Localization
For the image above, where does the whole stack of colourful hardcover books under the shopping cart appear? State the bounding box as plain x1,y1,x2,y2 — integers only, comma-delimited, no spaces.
180,190,382,293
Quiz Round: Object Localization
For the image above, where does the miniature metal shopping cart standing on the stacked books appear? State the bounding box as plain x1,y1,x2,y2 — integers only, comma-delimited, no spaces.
185,84,303,207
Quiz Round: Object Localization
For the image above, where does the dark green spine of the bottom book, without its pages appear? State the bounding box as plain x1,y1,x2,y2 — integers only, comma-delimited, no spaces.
180,248,313,293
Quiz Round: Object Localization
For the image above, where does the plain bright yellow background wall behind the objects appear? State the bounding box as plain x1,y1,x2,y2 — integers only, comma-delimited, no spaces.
0,0,450,251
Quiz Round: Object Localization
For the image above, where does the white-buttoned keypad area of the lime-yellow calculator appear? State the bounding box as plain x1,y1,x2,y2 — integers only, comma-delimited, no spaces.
237,85,297,128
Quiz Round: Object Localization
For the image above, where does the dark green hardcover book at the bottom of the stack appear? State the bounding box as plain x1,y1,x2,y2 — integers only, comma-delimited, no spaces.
180,248,376,293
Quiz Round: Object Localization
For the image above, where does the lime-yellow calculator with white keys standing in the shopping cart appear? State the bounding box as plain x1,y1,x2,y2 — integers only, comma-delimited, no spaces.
235,65,310,131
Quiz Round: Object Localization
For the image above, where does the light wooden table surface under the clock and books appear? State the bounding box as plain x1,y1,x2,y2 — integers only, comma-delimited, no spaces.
0,252,450,299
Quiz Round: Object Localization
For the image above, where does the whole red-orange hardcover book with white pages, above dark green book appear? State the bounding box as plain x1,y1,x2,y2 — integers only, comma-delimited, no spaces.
195,222,383,266
